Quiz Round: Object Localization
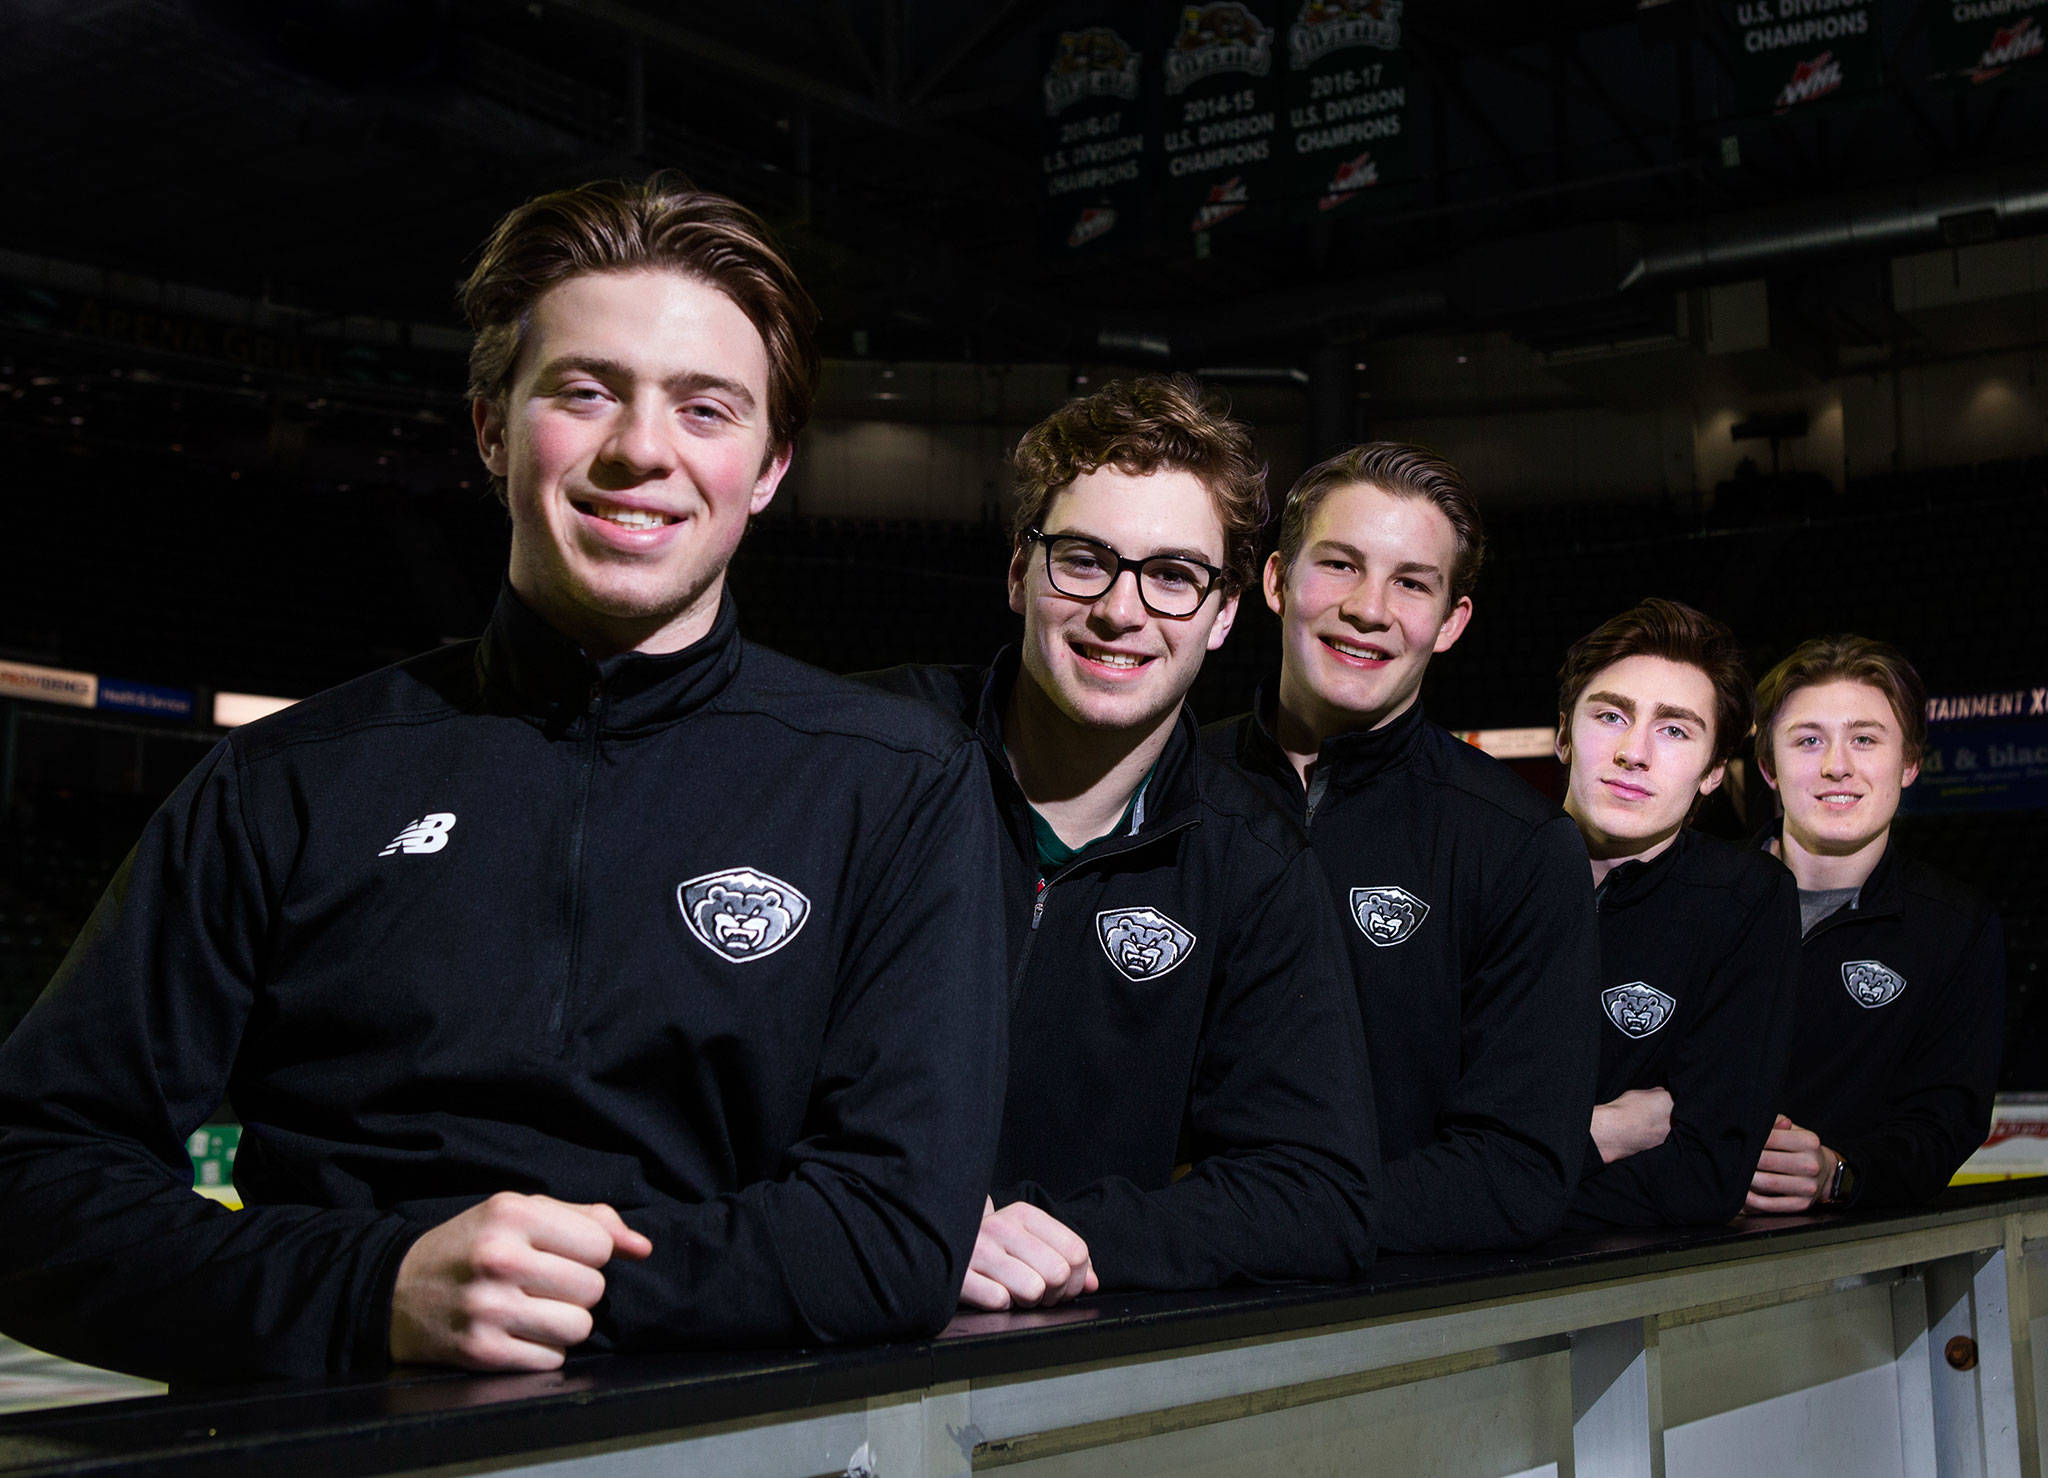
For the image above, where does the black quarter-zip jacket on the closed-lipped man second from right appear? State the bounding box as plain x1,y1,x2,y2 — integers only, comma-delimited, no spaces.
1567,829,1798,1226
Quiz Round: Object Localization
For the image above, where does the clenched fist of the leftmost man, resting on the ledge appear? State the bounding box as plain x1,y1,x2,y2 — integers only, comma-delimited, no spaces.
391,1191,653,1370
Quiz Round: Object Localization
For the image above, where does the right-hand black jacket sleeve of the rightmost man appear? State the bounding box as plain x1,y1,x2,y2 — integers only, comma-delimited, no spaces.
1829,909,2005,1206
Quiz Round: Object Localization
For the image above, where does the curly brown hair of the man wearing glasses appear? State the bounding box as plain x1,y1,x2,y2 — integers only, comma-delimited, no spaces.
1010,375,1266,592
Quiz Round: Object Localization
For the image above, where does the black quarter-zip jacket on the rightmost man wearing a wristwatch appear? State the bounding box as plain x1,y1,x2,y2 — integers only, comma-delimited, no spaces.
1765,835,2005,1206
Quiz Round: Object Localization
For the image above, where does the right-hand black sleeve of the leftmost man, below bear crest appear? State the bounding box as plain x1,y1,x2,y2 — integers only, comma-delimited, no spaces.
590,739,1006,1349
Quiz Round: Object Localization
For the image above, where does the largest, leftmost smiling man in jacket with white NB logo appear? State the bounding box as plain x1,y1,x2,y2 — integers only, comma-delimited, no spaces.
0,176,1004,1382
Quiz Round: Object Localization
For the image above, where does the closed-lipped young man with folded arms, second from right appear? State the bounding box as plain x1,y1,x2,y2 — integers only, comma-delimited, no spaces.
1556,600,1798,1226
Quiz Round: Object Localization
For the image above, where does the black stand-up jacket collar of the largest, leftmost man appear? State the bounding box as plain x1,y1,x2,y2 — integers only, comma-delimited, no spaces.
477,581,741,733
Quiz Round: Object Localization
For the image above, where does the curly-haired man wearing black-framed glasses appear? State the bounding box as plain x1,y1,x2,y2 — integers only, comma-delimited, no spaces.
877,377,1374,1308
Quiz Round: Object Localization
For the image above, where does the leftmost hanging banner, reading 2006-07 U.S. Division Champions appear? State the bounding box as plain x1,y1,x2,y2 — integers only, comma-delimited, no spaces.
1040,27,1147,256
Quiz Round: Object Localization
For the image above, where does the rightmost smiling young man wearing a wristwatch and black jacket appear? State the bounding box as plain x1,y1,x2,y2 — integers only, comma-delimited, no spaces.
1749,637,2005,1212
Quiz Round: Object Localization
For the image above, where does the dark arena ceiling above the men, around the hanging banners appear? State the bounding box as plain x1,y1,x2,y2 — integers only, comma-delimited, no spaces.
0,0,2048,362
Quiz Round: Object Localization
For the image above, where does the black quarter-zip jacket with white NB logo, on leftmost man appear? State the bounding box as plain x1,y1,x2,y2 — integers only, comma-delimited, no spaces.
0,592,1004,1382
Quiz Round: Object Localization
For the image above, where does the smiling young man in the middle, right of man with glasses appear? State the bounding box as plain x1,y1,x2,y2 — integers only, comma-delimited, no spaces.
1206,442,1599,1253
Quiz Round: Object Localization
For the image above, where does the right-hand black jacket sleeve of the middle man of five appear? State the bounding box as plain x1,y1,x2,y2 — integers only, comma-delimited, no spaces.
1378,815,1599,1253
